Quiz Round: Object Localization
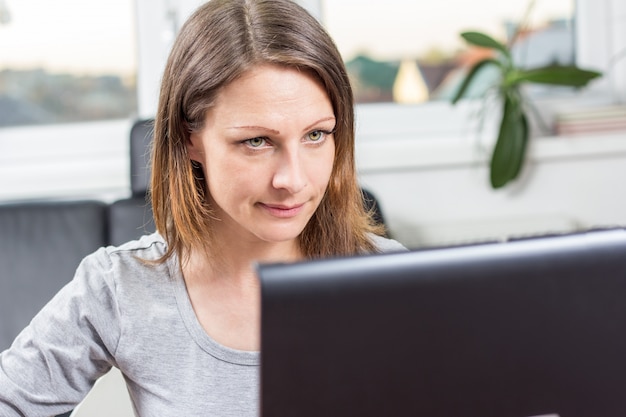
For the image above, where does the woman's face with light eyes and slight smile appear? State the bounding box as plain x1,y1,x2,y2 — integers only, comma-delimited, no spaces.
189,65,335,242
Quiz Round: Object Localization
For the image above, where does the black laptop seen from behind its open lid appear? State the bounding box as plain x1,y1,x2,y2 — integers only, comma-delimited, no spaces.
257,229,626,417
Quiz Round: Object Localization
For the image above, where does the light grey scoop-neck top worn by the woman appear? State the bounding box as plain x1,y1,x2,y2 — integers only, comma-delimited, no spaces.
0,234,404,417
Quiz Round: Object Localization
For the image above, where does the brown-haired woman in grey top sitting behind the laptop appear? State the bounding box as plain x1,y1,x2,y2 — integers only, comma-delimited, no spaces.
0,0,403,417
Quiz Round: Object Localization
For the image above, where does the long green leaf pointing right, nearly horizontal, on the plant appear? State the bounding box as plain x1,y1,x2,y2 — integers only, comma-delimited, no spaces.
507,65,602,87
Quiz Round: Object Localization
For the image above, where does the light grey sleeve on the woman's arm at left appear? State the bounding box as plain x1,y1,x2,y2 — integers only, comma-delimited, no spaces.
0,249,121,417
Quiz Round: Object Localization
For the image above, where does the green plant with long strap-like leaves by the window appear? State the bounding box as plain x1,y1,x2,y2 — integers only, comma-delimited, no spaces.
452,32,601,188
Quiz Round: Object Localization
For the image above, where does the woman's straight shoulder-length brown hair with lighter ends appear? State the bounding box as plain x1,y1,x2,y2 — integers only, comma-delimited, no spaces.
151,0,382,260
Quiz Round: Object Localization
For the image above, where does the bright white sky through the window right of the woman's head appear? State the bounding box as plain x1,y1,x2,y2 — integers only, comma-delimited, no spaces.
323,0,574,60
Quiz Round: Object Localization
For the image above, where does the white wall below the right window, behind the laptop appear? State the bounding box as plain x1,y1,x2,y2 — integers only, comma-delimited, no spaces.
357,128,626,247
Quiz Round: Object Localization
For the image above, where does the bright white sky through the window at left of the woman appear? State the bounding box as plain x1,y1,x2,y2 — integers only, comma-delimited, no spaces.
0,0,136,75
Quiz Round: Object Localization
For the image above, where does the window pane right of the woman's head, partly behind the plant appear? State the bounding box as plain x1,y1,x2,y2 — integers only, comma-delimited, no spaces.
323,0,574,103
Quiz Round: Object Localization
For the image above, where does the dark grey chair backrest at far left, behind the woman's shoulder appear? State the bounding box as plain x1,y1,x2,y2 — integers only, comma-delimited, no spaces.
0,201,107,351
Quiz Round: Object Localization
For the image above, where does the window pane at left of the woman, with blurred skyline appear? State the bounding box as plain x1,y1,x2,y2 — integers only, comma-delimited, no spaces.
0,0,137,126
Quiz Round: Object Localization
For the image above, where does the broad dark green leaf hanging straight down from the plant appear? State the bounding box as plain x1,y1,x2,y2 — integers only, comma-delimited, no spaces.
490,90,529,188
